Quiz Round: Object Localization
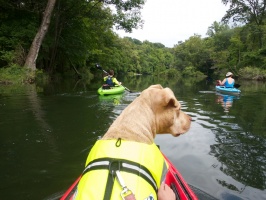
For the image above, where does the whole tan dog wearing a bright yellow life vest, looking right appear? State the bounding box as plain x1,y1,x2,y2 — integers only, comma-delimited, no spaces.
74,85,191,200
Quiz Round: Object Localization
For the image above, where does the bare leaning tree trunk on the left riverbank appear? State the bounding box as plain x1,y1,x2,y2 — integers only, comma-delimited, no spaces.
24,0,56,71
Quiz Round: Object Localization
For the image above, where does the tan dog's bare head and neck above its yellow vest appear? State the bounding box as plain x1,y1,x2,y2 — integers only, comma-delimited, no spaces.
103,85,191,144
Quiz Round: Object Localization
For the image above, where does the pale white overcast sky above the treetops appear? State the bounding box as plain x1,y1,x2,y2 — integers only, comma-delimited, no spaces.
115,0,229,48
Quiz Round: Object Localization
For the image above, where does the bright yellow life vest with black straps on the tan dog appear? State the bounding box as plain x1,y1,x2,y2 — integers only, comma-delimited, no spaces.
74,139,168,200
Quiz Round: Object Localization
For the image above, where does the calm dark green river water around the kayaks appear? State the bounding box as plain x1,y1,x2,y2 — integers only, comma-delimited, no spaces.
0,76,266,200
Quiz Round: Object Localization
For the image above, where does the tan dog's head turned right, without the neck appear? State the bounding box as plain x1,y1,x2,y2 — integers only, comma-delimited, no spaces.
140,85,191,137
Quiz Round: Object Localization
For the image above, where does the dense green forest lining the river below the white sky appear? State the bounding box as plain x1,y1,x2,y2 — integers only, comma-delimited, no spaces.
0,0,266,83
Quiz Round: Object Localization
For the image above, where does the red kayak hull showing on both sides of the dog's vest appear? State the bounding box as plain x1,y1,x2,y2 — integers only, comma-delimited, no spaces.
60,155,198,200
